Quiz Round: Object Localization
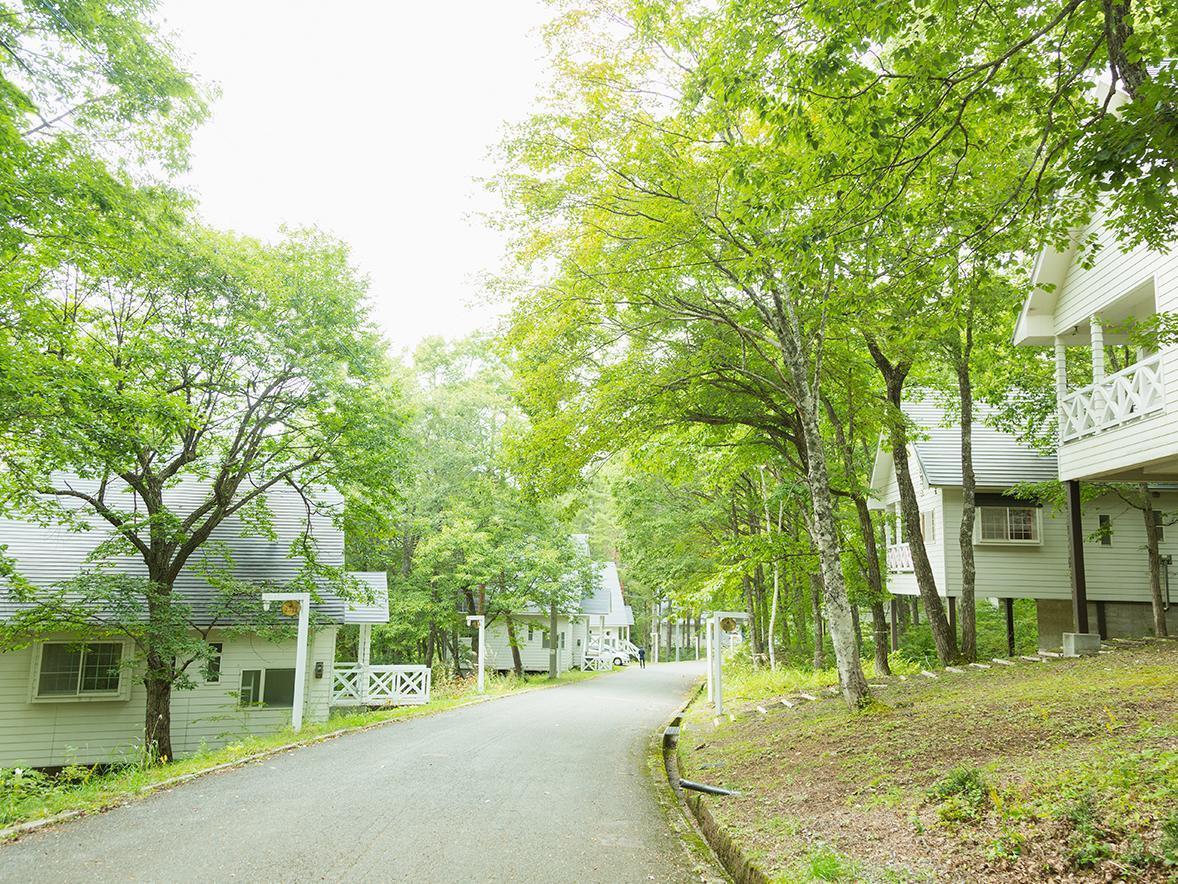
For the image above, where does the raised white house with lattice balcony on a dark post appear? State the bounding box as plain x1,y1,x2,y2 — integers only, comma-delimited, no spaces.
1014,206,1178,638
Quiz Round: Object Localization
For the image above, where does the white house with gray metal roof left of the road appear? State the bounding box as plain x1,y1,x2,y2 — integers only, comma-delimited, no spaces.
0,483,389,767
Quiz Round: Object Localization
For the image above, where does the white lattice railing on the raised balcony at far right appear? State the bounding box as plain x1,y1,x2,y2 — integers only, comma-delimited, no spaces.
1059,354,1165,442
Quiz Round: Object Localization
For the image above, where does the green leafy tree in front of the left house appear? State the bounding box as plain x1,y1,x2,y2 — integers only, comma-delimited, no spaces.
0,226,399,758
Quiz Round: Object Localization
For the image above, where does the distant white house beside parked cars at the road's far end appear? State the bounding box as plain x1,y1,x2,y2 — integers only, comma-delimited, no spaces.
473,534,634,672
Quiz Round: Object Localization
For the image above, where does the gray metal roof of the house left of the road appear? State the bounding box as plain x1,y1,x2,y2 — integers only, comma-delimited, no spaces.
0,479,388,624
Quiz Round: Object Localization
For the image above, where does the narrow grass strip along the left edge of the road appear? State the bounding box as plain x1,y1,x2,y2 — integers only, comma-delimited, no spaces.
0,669,601,829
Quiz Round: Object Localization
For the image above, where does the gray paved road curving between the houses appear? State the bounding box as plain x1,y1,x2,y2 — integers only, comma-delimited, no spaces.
0,664,702,882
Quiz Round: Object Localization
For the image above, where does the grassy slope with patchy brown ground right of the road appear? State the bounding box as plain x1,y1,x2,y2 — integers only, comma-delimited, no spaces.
680,642,1178,882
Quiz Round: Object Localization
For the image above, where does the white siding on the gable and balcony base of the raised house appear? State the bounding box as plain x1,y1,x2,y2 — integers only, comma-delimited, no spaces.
1054,213,1178,479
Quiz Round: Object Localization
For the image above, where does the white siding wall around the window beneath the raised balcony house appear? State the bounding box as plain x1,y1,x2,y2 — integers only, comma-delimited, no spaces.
939,488,1178,601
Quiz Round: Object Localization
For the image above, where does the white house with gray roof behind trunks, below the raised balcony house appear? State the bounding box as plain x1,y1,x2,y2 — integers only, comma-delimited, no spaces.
872,401,1178,648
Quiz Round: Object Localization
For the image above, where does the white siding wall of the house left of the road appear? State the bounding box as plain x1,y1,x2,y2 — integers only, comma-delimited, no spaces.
0,627,336,767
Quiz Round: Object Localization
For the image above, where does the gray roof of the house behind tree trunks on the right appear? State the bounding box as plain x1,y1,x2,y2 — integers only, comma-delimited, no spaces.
904,398,1059,488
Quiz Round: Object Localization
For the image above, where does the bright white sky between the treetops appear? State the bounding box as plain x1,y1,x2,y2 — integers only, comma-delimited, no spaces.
160,0,549,349
